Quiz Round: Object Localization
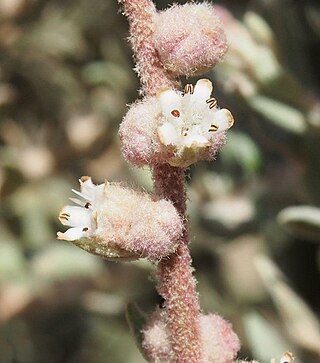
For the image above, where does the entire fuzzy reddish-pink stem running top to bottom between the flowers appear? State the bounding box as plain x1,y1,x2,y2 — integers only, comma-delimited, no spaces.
120,0,201,363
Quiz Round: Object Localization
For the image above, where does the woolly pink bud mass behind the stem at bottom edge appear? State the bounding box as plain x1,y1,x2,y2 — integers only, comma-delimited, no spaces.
142,309,240,363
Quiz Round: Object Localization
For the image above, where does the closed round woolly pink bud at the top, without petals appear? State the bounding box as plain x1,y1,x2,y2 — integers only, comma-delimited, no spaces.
154,3,228,76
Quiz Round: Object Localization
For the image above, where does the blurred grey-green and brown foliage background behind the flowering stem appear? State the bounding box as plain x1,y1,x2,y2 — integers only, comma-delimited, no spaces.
0,0,320,363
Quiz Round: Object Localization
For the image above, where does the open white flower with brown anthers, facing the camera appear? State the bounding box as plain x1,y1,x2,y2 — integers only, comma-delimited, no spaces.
157,79,234,166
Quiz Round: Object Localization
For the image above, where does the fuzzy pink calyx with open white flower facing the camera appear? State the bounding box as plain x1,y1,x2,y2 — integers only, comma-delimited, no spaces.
120,79,234,167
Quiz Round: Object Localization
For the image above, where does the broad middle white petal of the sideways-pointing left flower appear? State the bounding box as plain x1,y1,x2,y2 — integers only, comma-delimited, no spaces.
59,205,91,227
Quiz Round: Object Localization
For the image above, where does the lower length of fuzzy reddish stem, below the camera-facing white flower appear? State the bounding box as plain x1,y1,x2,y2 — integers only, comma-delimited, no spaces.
153,165,201,363
